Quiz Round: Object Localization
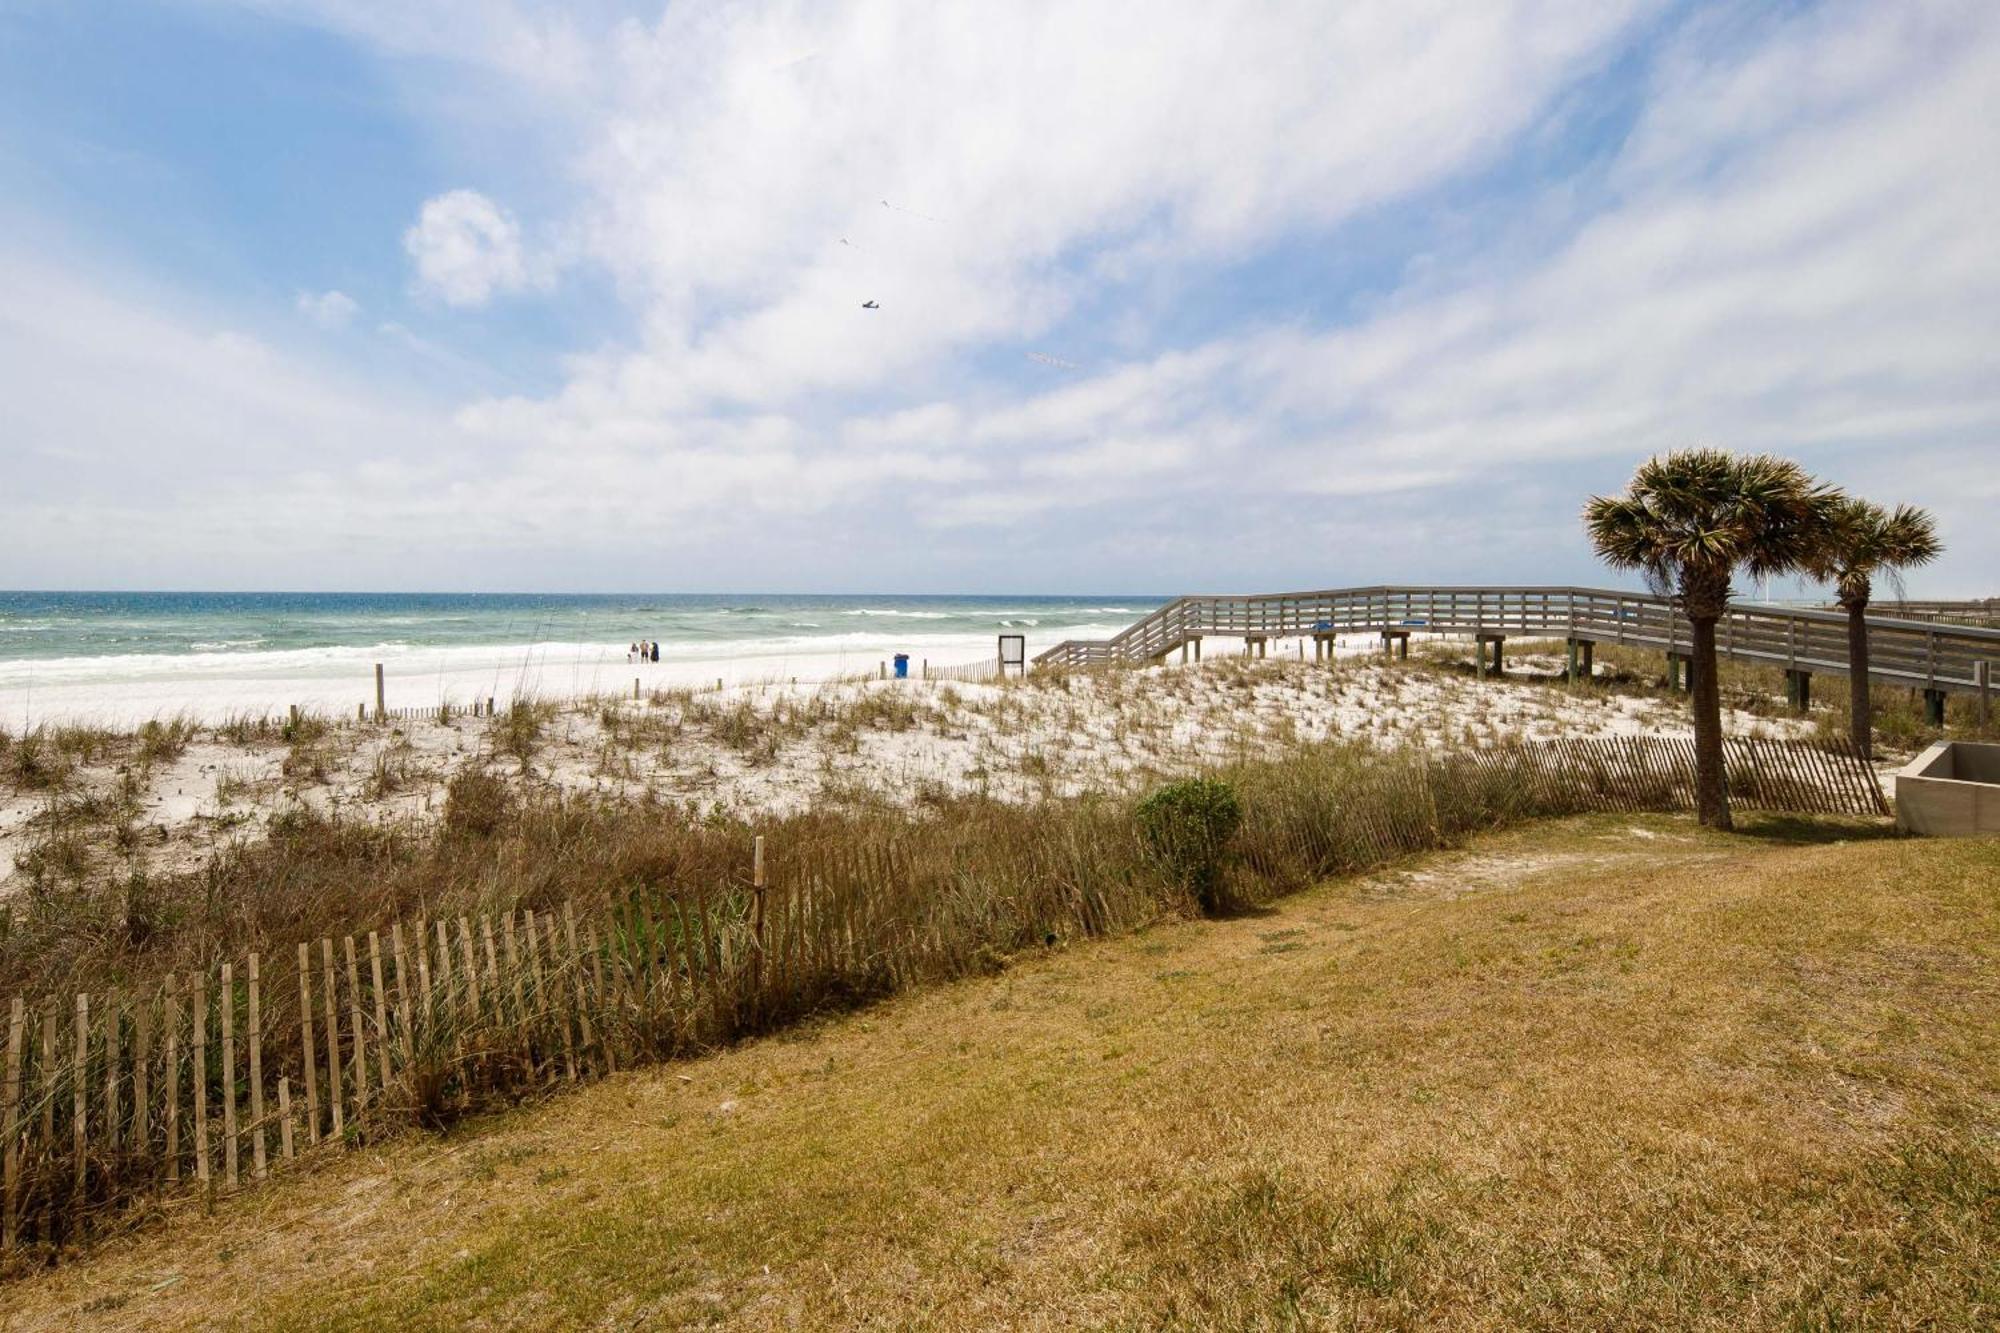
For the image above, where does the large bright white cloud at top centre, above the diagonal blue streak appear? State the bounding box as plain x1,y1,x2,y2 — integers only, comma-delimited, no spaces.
540,0,1650,410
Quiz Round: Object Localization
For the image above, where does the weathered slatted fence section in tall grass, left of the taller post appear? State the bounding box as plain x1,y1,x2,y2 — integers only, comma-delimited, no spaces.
0,872,720,1249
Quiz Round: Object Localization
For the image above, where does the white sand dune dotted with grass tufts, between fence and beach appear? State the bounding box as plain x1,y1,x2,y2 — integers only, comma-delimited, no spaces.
0,638,1806,895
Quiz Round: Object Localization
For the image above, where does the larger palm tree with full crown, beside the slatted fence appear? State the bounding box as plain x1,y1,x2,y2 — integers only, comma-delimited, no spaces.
1584,448,1838,829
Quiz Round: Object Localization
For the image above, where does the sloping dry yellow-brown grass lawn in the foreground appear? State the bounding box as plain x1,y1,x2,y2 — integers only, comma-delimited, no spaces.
0,817,2000,1329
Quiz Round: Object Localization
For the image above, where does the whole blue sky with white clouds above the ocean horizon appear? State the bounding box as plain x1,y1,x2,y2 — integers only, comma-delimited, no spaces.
0,0,2000,596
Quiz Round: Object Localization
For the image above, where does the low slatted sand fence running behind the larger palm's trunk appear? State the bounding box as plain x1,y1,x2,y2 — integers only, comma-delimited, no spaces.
1464,737,1890,815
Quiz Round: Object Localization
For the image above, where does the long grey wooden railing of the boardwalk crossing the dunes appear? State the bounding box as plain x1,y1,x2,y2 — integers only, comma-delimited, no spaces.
1034,586,2000,693
